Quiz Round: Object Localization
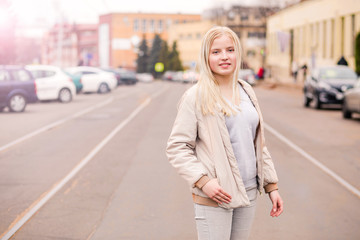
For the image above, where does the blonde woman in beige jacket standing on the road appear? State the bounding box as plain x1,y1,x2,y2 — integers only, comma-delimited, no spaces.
167,27,283,240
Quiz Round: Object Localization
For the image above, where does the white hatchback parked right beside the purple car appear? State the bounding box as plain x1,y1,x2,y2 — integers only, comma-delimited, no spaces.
25,65,76,103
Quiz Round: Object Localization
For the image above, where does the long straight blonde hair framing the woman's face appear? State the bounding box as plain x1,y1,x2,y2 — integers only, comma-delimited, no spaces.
197,26,241,116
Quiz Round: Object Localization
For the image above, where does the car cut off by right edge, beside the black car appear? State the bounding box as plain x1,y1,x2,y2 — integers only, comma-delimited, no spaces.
342,78,360,118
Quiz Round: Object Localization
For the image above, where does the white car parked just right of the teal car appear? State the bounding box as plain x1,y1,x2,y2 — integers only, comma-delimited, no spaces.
65,66,117,93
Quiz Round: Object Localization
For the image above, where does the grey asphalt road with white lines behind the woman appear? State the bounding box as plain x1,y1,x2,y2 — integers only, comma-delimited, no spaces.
0,81,360,240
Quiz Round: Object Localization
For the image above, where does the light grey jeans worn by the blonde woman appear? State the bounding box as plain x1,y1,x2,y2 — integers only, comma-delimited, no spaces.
194,187,257,240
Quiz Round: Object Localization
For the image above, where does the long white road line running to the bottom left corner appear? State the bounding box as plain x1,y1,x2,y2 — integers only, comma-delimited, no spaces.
0,87,168,240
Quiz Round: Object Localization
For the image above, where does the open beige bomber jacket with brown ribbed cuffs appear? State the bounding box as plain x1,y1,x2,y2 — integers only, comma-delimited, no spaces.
166,80,278,208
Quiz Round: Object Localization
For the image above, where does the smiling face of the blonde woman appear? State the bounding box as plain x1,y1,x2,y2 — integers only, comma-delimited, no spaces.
209,35,236,79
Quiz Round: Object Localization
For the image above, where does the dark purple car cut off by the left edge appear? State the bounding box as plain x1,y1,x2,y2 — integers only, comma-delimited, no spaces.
0,66,38,112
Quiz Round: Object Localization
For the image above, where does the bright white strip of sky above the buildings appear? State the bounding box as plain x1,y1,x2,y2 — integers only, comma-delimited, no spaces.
9,0,276,25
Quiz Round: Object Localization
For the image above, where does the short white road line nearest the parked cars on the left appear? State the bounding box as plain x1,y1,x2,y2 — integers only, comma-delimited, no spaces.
0,97,114,152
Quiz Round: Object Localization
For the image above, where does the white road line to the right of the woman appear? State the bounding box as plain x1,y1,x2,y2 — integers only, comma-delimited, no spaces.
264,123,360,198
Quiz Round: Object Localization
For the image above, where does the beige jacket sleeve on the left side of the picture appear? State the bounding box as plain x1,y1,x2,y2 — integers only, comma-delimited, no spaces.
166,89,206,187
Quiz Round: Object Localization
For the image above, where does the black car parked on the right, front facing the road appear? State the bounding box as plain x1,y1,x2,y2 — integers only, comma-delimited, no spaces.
304,66,357,109
